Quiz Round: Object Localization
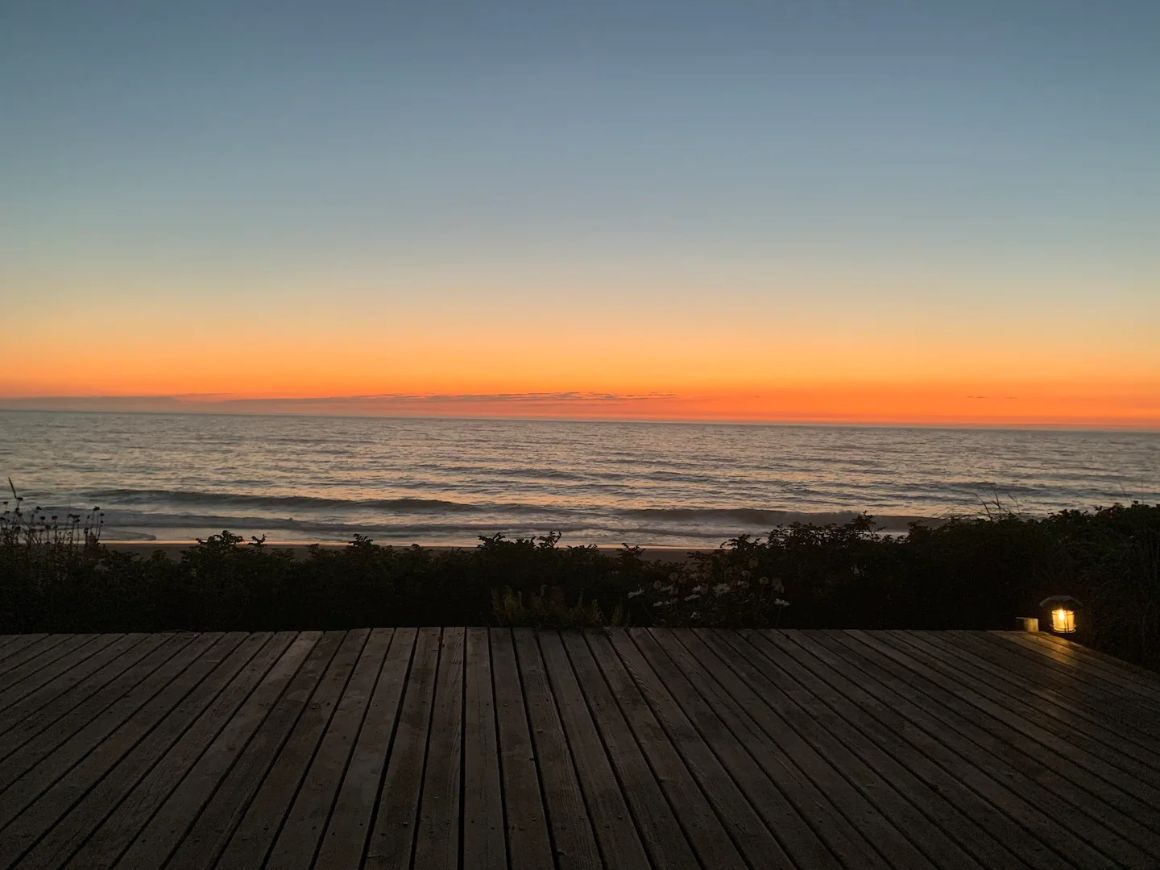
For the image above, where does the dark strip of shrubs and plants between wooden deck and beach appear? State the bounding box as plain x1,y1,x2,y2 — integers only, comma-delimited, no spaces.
0,493,1160,669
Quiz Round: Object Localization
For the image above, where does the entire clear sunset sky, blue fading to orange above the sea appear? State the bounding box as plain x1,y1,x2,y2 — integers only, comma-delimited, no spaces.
0,0,1160,428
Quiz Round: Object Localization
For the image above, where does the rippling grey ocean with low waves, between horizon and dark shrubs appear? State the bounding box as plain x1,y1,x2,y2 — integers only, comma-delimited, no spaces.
0,412,1160,546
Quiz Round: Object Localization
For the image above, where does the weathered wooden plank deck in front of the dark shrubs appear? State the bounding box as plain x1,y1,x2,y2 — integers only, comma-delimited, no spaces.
0,629,1160,870
